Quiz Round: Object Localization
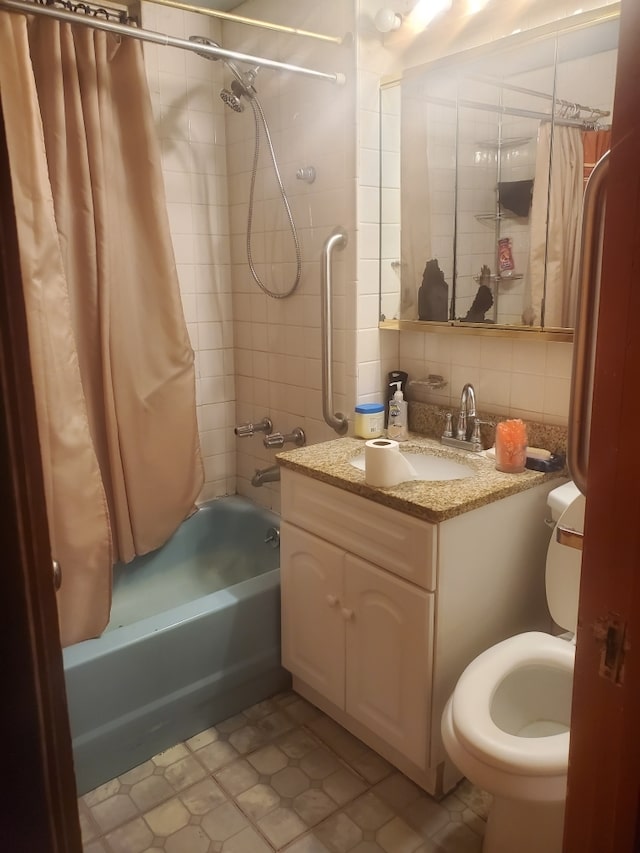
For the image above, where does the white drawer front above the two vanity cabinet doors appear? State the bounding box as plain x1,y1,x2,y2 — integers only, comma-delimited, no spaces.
281,468,438,590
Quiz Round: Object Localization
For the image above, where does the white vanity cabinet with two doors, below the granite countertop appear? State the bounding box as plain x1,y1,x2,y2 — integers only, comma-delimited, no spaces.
280,468,558,794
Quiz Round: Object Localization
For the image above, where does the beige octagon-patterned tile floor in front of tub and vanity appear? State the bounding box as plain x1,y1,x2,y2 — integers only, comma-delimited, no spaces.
79,692,489,853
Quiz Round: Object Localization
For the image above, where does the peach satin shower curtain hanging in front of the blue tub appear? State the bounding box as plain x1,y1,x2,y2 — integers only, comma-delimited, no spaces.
0,13,203,645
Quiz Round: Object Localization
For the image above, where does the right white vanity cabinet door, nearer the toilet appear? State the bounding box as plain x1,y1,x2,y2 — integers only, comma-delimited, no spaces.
341,555,433,767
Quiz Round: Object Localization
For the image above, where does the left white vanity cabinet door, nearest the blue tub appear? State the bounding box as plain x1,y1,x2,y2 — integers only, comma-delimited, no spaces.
280,522,344,708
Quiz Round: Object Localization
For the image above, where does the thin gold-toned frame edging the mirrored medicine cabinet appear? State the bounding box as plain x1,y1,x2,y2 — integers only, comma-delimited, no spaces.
378,2,621,342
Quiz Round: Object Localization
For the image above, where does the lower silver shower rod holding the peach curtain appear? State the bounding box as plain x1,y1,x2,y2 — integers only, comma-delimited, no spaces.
0,0,346,85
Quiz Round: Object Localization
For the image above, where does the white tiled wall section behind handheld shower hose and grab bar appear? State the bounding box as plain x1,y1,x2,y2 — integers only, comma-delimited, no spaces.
222,0,356,509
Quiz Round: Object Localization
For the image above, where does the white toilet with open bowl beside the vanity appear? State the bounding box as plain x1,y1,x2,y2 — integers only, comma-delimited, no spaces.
442,482,585,853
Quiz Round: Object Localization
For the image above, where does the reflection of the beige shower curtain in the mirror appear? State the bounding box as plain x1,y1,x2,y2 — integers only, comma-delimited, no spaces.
523,122,583,328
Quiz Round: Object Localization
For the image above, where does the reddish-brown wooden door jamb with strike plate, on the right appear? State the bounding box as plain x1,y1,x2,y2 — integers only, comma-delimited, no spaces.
564,0,640,853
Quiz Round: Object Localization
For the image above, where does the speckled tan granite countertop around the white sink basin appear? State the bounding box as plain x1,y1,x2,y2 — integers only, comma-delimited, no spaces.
276,433,566,523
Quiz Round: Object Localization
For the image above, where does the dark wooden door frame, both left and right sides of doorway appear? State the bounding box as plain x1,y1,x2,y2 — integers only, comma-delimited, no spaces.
0,0,640,853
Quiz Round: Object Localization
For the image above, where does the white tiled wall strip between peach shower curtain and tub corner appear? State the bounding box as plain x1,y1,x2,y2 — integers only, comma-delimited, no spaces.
142,3,236,500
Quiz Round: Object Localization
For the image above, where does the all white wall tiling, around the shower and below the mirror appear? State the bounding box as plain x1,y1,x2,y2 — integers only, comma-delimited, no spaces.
143,0,610,508
